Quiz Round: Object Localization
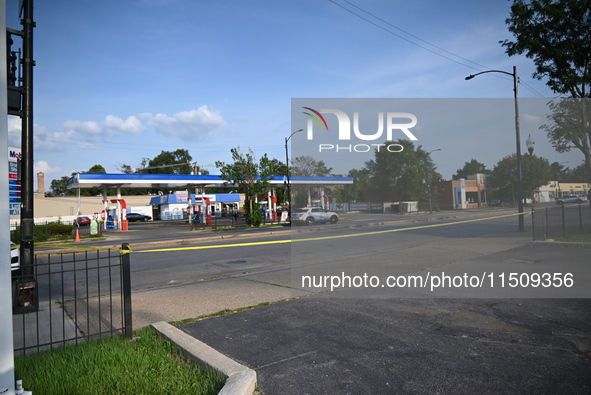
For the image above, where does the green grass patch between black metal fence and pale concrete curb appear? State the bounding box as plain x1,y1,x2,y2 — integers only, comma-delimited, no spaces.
15,327,225,395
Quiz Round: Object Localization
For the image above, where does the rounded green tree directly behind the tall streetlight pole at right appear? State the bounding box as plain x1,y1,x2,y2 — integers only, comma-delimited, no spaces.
488,154,553,204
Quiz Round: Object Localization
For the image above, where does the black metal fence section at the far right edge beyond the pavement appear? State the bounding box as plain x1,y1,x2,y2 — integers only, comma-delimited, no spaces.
532,203,591,241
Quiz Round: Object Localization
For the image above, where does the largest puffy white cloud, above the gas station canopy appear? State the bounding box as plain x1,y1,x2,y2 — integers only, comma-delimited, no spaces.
147,106,226,140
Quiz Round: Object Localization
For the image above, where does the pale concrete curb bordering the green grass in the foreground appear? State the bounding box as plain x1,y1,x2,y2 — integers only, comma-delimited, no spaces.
151,321,256,395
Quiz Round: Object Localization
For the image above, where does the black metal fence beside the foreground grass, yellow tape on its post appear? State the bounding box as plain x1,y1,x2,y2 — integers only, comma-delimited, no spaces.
13,244,132,353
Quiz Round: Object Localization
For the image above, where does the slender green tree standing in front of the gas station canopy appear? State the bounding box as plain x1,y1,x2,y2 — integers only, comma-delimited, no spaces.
215,147,276,226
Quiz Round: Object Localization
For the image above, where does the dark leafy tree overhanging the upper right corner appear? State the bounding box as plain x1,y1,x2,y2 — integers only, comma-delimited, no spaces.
501,0,591,182
